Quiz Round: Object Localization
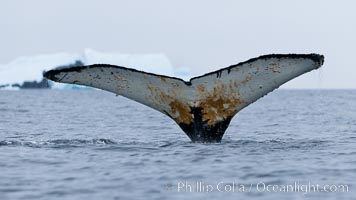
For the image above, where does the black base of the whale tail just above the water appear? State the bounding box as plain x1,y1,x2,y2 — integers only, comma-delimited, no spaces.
178,107,232,143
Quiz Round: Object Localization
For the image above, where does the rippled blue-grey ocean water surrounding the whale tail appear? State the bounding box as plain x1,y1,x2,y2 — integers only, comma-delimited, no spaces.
0,90,356,200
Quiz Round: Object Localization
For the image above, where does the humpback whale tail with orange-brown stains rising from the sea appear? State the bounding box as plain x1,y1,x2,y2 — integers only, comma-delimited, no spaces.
44,54,324,142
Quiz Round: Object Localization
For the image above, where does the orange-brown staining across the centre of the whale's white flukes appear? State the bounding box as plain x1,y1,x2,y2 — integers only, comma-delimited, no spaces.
153,78,249,126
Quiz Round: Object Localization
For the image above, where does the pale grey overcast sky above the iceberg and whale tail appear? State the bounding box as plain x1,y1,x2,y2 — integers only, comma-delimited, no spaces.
0,0,356,88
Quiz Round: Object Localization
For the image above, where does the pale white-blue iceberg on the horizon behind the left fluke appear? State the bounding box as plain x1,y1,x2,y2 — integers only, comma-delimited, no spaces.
0,49,190,89
